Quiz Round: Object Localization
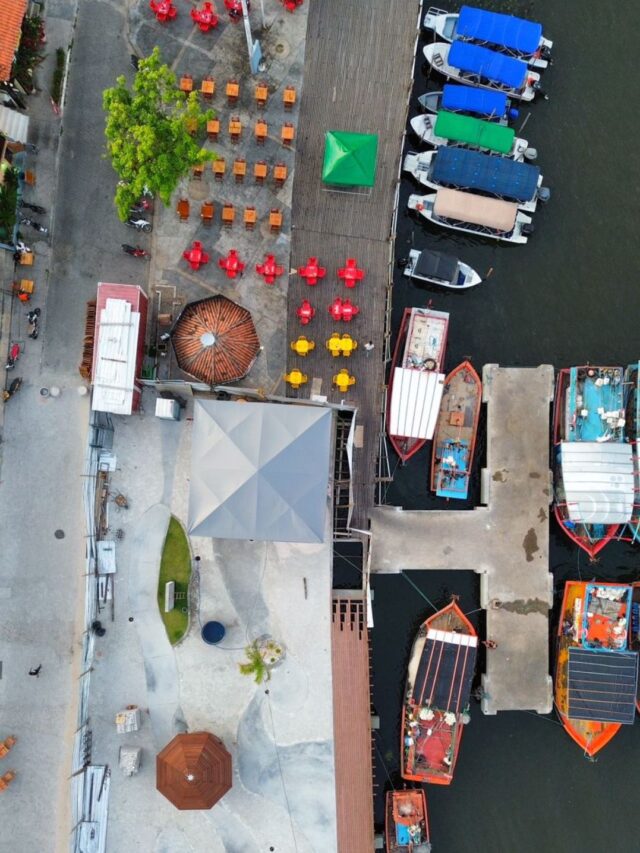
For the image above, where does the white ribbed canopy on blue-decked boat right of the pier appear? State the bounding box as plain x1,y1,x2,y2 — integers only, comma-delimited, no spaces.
560,441,634,524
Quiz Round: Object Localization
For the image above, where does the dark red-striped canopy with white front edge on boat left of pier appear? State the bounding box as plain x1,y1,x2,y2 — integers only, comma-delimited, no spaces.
413,628,478,713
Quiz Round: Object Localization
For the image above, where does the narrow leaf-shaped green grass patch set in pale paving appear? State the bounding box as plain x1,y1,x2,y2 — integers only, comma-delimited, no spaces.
158,515,191,646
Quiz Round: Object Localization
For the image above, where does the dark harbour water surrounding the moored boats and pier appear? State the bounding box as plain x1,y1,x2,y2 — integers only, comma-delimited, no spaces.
372,0,640,853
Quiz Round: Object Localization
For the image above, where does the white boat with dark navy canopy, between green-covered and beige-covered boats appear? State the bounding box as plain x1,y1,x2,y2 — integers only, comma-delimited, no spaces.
402,148,551,213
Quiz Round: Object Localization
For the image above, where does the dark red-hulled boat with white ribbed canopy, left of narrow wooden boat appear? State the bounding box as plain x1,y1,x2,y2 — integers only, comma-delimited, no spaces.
387,308,449,462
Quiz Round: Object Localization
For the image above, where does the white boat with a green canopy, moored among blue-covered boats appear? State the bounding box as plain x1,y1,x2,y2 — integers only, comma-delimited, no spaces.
409,110,538,161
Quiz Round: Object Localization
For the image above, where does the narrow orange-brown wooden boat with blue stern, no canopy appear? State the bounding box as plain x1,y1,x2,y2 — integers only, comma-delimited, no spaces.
431,361,482,500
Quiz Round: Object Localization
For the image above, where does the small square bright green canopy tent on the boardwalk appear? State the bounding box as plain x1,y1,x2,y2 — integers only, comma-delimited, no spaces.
322,130,378,187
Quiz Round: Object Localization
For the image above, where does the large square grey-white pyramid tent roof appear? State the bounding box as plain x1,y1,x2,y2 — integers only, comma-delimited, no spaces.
188,400,332,542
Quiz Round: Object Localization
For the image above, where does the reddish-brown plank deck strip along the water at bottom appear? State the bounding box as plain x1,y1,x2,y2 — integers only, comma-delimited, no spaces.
331,596,374,853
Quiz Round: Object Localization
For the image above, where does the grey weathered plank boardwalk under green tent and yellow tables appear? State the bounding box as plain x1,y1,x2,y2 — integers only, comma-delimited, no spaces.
287,0,420,528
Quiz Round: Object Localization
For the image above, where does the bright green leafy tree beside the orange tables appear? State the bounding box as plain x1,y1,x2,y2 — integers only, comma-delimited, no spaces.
102,47,216,221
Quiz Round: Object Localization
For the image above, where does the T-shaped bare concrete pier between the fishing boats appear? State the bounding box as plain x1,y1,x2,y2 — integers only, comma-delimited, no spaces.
371,364,553,714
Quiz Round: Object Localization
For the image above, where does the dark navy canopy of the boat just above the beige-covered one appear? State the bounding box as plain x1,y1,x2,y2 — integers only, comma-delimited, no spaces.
429,147,540,202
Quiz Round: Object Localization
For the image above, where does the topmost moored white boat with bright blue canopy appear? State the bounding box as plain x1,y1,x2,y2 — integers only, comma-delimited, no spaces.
423,6,553,71
